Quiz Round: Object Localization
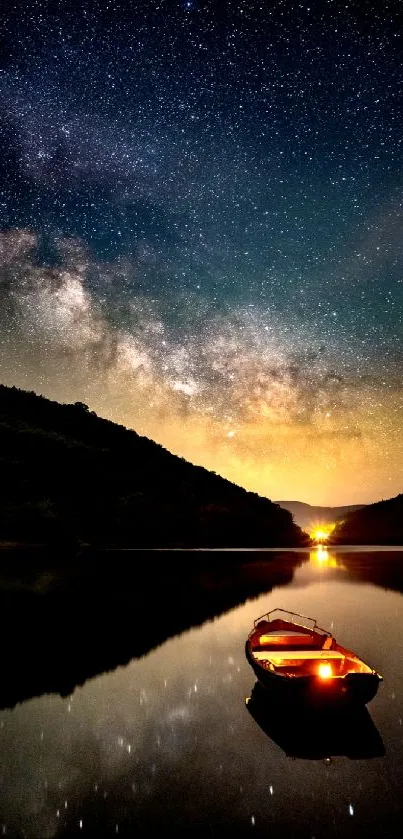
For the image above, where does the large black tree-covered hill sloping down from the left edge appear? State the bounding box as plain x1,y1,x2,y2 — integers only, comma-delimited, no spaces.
0,385,307,547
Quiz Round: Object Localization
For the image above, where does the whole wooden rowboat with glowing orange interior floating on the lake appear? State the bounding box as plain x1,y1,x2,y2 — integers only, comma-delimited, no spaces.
246,609,382,704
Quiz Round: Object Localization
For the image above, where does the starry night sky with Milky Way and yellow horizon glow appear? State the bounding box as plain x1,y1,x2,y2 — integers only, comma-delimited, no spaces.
0,0,403,504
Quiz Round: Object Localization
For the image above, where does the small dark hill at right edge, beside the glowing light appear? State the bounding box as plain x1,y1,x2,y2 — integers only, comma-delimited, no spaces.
331,495,403,545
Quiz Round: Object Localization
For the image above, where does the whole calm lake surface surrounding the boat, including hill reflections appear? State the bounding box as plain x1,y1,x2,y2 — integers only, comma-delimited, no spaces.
0,548,403,839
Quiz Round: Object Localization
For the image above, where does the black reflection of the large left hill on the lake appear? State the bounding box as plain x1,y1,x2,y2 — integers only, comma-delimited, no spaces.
0,551,307,708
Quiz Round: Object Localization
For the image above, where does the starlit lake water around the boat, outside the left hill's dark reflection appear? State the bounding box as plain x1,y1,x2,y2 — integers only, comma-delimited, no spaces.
0,549,403,839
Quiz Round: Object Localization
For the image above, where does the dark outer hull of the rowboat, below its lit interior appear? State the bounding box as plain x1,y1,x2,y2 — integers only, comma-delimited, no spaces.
245,641,380,707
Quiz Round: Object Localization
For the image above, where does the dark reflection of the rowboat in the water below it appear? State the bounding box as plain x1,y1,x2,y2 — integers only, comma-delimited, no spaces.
245,682,385,760
